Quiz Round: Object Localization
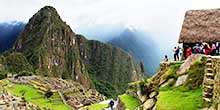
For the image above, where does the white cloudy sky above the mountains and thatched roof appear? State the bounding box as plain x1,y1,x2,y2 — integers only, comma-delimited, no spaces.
0,0,220,56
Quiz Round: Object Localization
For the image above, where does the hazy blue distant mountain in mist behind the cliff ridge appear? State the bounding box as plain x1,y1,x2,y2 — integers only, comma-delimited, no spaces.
108,28,160,75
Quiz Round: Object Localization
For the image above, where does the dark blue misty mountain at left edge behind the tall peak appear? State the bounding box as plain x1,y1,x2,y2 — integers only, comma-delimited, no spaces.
0,21,25,52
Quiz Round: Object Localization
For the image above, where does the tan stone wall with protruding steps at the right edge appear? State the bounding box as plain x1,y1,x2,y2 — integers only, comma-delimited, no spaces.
203,57,220,110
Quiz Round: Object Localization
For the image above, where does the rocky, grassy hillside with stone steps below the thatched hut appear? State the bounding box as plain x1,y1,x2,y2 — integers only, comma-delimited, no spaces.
120,54,220,110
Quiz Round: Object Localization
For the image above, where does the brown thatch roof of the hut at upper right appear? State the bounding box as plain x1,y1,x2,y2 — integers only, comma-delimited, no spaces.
179,9,220,43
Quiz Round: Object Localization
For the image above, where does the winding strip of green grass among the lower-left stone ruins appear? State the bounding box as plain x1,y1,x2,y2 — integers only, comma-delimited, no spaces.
2,81,71,110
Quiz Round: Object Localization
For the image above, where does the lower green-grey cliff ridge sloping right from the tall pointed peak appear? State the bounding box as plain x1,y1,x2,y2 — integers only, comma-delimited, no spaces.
77,35,143,96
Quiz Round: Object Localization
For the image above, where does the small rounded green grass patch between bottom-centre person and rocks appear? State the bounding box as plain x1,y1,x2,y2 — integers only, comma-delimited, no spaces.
119,94,140,110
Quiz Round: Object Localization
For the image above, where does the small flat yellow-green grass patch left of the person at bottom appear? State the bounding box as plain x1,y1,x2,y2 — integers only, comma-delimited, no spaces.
81,104,108,110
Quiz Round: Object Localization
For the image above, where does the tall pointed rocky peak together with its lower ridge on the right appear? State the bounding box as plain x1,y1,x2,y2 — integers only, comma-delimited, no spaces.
0,6,143,97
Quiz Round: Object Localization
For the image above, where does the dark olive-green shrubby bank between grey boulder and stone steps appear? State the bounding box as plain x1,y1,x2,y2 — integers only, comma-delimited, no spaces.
185,58,205,88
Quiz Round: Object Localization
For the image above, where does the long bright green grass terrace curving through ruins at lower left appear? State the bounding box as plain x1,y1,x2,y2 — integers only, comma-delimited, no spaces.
0,79,72,110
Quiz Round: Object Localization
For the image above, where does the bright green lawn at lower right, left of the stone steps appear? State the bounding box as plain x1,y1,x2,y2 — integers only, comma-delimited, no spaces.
156,86,202,110
